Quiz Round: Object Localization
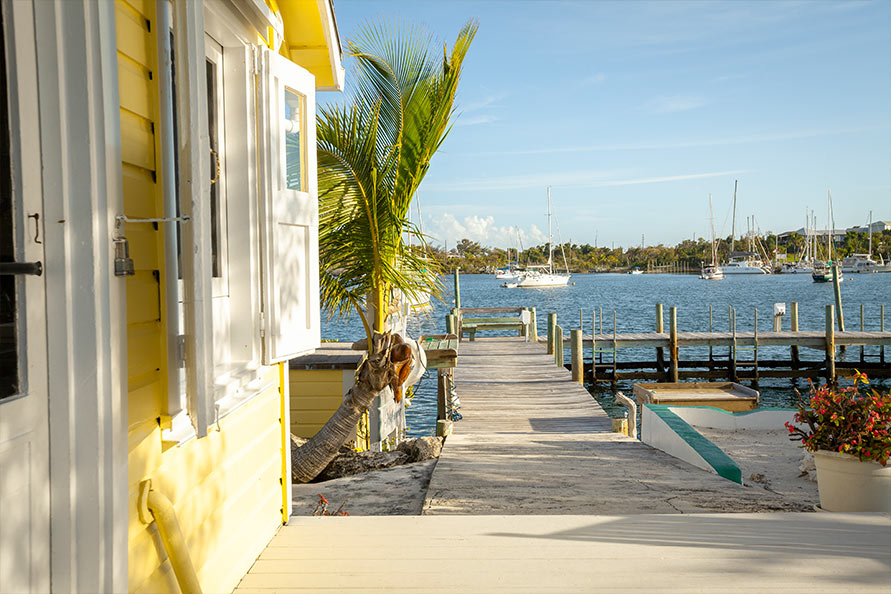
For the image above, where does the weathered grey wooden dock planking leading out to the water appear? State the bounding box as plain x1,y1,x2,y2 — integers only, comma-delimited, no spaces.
423,337,806,515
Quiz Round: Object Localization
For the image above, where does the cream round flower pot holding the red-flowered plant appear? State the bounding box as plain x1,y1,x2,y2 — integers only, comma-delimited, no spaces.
814,450,891,514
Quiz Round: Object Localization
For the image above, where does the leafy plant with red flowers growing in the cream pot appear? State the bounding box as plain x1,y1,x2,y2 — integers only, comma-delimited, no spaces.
786,371,891,466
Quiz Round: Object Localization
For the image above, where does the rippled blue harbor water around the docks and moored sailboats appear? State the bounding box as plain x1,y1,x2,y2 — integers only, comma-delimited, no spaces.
322,274,891,436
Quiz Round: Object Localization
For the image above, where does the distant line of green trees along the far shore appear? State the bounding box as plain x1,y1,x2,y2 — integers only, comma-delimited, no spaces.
428,231,891,273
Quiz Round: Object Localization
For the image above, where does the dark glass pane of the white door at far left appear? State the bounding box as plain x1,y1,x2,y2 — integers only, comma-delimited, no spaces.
0,11,19,399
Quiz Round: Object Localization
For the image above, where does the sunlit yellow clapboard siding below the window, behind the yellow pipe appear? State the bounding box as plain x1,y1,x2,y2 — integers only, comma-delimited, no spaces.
129,386,281,592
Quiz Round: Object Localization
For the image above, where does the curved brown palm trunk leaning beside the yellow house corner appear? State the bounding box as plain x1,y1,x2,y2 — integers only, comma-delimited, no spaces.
291,332,411,483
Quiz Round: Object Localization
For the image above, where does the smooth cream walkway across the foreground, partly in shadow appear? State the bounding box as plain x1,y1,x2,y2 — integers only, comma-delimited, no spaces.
236,513,891,594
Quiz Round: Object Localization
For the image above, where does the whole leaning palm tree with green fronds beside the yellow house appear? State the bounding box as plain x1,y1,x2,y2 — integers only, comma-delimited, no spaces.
292,22,477,481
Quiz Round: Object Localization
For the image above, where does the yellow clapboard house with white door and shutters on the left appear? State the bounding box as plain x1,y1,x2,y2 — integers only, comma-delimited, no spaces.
0,0,343,592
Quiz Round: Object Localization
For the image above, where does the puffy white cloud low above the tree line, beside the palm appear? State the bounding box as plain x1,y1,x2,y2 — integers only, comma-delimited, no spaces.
425,213,548,248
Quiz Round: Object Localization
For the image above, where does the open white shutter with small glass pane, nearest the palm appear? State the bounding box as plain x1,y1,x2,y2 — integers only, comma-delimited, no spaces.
258,48,321,365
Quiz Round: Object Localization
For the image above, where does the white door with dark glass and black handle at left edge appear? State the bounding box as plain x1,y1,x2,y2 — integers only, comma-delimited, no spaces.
0,0,50,592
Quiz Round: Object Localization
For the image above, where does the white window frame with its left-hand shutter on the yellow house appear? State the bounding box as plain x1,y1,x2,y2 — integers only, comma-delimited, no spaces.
163,0,306,443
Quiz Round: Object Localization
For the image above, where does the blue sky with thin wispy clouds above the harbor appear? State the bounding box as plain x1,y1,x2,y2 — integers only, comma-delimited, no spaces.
320,0,891,247
